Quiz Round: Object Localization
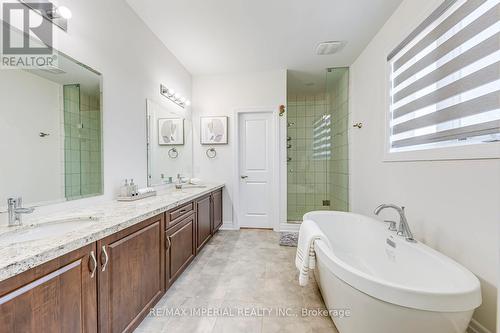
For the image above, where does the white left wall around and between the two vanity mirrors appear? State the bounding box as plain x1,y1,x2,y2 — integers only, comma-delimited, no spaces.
0,0,192,219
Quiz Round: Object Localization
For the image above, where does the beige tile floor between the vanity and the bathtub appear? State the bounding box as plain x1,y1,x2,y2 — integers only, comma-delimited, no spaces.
135,230,337,333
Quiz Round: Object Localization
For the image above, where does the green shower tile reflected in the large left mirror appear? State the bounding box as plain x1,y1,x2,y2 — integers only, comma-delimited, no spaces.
63,84,102,200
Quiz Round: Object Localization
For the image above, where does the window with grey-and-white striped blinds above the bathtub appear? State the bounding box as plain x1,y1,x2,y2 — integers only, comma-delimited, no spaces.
387,0,500,152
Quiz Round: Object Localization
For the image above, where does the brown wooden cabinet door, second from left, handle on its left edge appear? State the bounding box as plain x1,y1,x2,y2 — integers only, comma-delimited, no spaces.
97,214,165,333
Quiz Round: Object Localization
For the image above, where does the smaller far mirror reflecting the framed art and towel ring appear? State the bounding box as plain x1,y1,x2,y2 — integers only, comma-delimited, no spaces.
146,100,193,186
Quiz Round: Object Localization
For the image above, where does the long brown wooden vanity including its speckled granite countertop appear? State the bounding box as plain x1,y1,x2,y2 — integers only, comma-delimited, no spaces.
0,184,223,333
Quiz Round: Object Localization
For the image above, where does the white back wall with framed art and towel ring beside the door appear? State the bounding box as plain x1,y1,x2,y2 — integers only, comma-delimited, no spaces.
193,70,286,226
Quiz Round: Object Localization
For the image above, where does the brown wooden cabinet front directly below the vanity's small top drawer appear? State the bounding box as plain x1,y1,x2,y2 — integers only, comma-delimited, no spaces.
166,214,196,286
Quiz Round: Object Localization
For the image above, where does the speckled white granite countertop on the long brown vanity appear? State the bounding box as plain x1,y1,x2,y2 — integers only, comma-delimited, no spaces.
0,183,224,281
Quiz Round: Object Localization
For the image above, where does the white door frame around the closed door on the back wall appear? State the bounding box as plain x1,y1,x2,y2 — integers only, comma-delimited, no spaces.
233,106,281,231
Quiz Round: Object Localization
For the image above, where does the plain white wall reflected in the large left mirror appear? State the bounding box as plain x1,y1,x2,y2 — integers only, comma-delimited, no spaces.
0,70,64,204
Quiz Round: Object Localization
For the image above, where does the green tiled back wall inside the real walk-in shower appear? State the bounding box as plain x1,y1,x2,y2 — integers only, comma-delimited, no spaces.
287,94,330,221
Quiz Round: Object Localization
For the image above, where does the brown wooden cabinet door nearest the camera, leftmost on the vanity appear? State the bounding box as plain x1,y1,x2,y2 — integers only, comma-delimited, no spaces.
0,243,97,333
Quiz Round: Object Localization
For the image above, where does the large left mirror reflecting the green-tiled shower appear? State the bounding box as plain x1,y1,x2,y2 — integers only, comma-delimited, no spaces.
0,53,103,207
